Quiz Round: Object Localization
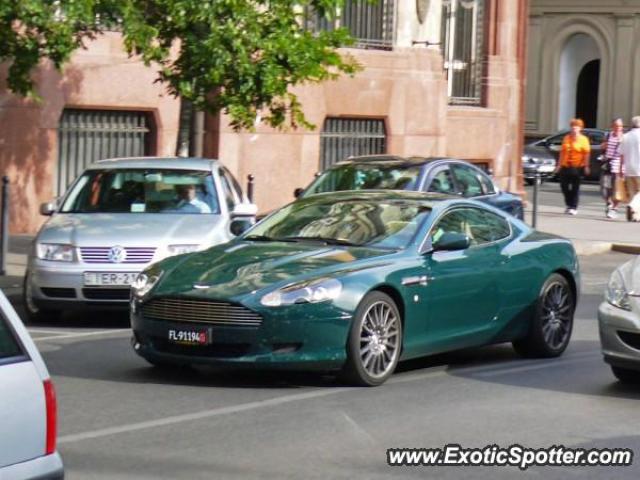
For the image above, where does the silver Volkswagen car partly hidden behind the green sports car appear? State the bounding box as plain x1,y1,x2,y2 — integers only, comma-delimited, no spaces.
24,158,257,319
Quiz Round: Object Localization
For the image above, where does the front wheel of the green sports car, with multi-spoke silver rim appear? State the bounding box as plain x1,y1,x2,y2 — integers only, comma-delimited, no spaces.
342,292,402,387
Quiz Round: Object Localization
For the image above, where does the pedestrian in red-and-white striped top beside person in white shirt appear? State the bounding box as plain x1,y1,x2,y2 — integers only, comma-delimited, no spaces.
600,118,624,218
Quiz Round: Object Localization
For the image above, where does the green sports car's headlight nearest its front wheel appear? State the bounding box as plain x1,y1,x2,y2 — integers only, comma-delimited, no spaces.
260,278,342,307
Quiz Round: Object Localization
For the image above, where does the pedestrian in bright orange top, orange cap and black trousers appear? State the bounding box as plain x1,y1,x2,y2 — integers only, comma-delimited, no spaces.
555,118,591,215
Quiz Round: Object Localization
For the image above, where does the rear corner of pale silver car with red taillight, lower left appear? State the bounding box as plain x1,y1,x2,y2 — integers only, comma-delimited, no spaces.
0,291,64,480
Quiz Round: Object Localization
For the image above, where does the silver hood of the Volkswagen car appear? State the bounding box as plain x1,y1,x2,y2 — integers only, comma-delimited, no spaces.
38,213,228,247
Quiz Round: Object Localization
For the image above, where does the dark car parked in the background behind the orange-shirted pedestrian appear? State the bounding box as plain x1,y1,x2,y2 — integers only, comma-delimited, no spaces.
522,128,607,180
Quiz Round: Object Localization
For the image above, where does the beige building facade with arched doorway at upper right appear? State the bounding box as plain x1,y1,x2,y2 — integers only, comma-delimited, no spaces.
525,0,640,136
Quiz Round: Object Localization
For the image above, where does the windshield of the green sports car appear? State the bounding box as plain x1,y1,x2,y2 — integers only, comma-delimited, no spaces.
244,199,431,249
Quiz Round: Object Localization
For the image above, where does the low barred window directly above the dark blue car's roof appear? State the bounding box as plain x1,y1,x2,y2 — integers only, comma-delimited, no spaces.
320,118,387,170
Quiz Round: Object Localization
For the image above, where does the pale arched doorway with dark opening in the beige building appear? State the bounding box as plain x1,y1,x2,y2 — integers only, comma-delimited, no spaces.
557,33,601,129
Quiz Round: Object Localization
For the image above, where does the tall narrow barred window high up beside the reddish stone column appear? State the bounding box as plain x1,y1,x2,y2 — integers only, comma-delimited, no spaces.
440,0,485,106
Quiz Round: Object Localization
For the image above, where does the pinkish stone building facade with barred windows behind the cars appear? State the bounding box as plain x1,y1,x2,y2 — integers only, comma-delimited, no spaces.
0,0,529,233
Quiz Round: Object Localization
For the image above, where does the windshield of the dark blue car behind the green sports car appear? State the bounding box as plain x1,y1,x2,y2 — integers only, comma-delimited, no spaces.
304,164,420,196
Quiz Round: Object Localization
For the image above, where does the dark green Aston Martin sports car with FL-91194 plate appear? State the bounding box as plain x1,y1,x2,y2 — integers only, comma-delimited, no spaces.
131,191,579,385
